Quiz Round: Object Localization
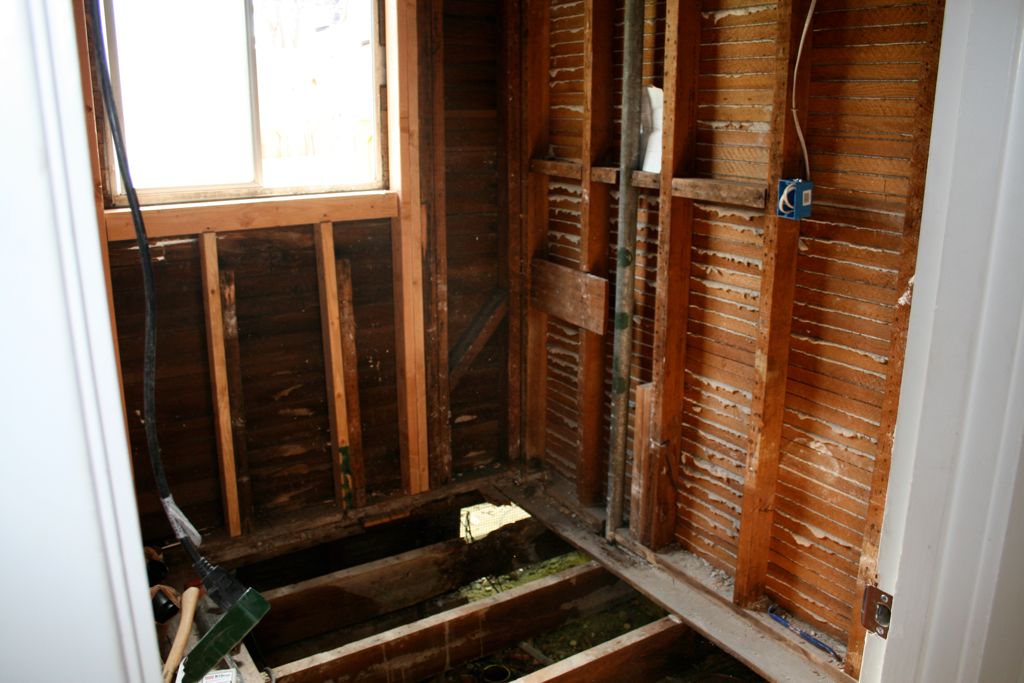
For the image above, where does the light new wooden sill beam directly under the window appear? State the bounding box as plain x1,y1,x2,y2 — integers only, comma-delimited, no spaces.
103,189,398,242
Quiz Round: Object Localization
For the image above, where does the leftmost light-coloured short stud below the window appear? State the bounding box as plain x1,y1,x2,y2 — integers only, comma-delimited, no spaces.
199,232,242,537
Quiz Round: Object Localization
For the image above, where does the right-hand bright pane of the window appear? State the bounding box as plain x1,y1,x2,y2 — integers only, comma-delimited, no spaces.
253,0,381,187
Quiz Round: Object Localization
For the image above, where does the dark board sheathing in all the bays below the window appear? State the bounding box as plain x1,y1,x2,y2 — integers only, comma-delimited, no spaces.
111,221,401,540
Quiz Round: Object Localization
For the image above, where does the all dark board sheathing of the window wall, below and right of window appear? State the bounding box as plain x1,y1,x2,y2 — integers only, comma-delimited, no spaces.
110,0,508,540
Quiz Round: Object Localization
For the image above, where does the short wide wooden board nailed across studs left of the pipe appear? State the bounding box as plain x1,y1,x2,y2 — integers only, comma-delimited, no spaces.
529,259,608,335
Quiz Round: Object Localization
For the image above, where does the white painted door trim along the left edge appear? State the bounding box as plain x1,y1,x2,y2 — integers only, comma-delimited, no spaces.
0,0,160,683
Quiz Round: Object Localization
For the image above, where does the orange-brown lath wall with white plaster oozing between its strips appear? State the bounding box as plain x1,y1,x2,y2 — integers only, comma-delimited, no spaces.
516,0,943,673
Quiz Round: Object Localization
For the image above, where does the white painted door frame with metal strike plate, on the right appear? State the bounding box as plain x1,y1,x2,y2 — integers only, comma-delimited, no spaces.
861,0,1024,683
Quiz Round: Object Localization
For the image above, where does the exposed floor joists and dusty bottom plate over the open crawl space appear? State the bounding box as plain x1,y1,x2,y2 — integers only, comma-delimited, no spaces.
224,476,853,683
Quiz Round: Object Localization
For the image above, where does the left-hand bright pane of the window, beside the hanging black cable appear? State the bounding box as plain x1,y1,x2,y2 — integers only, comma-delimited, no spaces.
113,0,255,188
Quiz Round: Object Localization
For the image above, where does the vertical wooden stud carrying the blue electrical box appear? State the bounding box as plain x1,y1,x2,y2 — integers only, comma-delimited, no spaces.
733,0,810,606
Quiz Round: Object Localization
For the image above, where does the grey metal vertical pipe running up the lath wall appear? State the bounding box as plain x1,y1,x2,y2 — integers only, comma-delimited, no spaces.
605,0,643,541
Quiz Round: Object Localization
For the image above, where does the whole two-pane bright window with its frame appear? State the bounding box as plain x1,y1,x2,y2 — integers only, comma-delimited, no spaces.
104,0,383,204
